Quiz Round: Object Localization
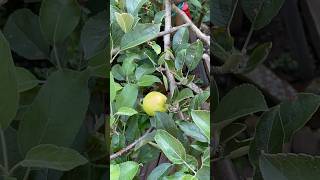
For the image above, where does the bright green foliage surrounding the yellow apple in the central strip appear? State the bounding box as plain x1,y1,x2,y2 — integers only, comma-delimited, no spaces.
110,0,210,180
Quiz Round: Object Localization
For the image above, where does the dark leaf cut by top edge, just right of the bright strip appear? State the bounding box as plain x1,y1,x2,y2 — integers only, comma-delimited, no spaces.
210,0,235,27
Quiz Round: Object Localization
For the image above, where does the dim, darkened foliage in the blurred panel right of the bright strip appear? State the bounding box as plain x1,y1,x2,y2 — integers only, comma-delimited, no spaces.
211,0,320,180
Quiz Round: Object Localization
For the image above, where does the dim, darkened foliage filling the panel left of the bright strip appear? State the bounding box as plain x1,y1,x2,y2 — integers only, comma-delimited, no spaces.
0,0,108,179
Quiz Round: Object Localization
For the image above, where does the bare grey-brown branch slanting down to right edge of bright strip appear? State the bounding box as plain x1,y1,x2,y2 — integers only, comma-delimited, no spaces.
172,4,210,46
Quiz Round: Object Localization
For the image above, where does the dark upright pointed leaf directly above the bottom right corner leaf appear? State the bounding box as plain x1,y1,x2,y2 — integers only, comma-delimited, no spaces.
249,106,284,168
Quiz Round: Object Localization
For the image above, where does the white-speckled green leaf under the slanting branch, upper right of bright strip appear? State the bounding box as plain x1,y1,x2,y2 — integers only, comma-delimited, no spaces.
185,40,203,71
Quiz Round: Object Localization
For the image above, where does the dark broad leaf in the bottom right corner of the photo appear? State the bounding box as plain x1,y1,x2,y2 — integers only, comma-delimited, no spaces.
260,154,320,180
